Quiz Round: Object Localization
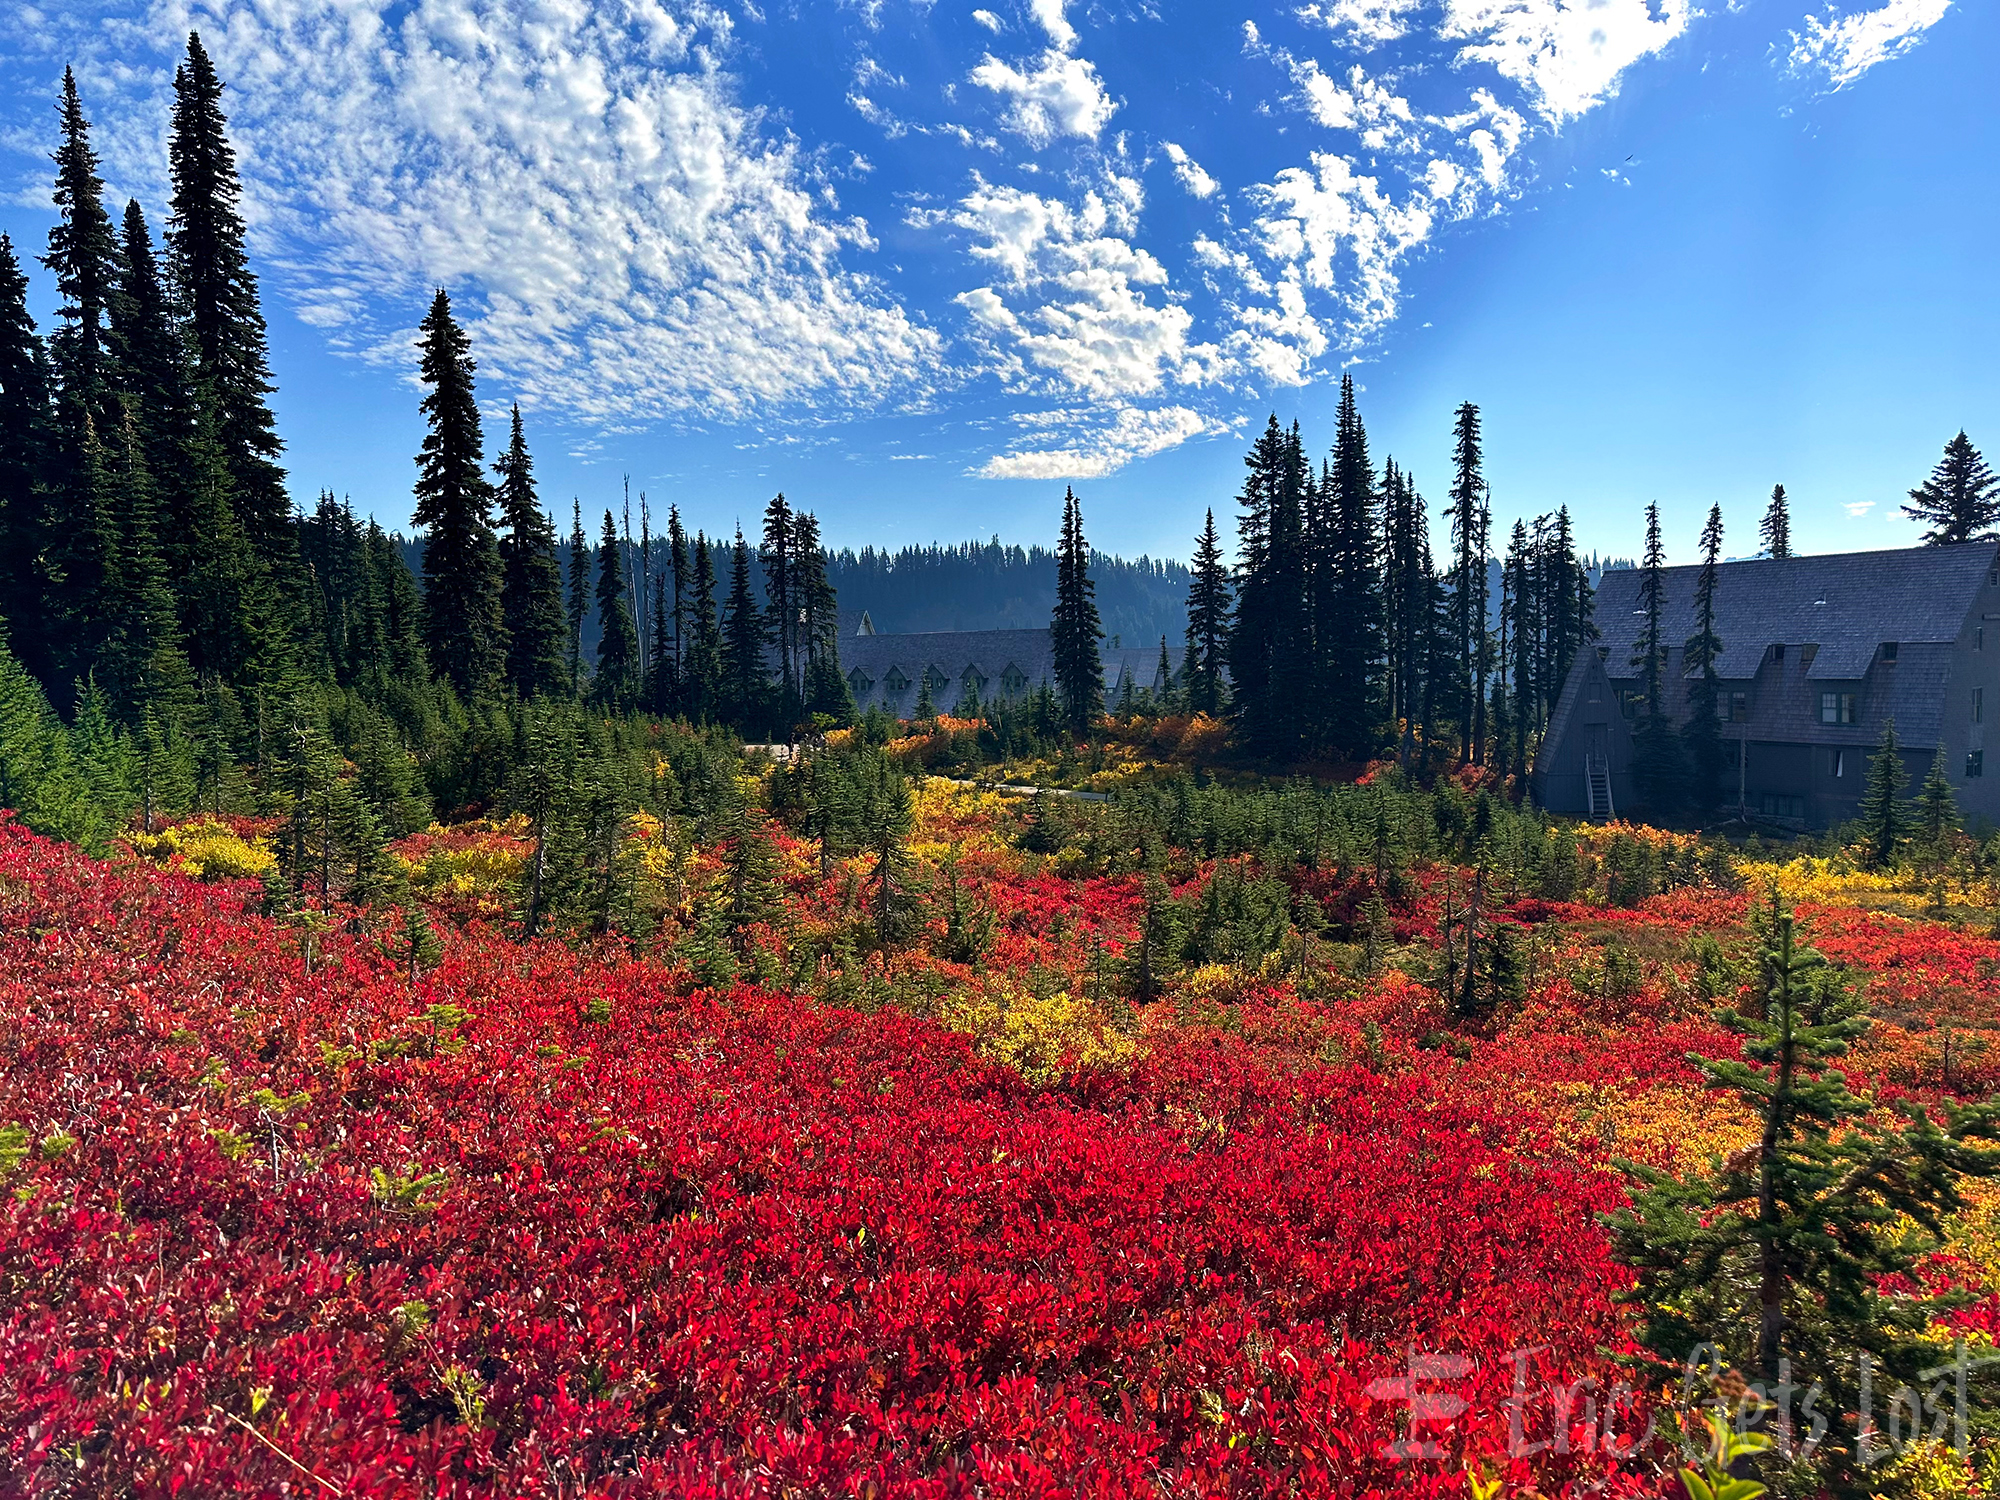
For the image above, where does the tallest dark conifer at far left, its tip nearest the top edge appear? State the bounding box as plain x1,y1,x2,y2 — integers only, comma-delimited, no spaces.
166,32,292,576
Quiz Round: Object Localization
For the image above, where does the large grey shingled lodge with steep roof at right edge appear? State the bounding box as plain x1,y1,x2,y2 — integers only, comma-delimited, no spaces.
1534,542,2000,828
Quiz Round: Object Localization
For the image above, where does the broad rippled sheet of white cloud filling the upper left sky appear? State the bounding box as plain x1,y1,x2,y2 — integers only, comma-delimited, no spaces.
9,0,938,426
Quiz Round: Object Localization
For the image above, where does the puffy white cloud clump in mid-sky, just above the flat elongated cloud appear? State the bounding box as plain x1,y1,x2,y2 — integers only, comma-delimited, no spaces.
952,176,1220,398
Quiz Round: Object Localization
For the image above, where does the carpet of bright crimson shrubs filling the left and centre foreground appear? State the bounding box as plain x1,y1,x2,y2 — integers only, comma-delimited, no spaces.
0,826,1656,1500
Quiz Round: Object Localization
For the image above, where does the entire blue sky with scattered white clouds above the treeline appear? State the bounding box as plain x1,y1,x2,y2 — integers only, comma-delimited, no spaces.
0,0,2000,560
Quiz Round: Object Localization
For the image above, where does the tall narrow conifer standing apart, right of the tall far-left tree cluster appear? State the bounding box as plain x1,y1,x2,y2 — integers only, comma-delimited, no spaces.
412,288,506,698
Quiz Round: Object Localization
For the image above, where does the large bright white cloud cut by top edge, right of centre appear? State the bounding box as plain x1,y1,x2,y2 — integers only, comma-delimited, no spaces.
1438,0,1692,124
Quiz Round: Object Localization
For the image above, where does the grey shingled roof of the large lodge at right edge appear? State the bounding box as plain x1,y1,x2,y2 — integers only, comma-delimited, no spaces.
1596,542,2000,680
